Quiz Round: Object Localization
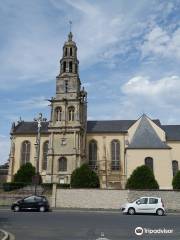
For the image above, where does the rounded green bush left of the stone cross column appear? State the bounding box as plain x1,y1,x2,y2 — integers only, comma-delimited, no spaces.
14,163,36,183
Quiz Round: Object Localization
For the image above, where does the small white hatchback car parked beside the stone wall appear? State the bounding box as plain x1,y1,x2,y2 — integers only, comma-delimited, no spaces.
121,197,165,216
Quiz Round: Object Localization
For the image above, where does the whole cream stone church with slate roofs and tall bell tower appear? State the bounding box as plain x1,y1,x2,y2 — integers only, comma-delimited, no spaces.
8,32,180,189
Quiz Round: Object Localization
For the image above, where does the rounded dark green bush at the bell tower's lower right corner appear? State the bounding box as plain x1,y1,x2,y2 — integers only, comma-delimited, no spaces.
71,164,100,188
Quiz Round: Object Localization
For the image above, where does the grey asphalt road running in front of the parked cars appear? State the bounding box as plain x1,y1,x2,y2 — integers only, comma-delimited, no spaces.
0,209,180,240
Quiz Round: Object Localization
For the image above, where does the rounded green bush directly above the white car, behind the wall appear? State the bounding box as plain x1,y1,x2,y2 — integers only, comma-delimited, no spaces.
126,165,159,189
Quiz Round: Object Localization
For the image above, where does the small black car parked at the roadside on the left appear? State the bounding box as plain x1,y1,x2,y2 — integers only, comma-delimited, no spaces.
11,195,49,212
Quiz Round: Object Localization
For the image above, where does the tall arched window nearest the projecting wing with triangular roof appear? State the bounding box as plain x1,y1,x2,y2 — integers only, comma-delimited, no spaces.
111,140,120,170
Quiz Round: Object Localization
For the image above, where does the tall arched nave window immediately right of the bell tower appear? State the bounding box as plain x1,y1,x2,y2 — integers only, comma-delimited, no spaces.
89,140,97,169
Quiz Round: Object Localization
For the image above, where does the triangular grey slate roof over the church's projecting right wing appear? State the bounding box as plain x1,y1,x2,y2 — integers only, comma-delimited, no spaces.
128,115,170,149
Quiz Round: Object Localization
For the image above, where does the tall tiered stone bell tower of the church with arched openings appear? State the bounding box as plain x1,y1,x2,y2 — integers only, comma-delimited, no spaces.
47,31,87,183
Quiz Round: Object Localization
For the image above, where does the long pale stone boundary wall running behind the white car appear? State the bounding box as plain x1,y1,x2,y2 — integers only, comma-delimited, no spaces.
52,188,180,210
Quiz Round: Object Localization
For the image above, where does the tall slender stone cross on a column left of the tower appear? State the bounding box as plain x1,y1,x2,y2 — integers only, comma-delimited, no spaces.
34,113,47,195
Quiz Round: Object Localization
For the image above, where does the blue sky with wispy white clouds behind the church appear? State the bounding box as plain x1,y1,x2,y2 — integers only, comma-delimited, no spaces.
0,0,180,163
